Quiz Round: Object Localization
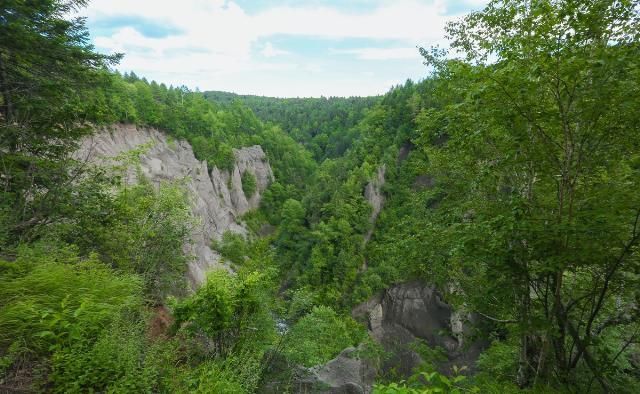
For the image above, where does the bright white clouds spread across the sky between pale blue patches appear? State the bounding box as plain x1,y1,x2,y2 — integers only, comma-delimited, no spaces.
83,0,464,95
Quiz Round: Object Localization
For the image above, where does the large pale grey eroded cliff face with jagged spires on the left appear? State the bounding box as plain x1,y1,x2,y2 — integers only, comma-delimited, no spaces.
77,125,273,287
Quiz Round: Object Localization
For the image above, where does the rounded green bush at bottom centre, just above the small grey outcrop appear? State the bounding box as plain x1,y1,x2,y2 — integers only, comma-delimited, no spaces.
283,306,366,367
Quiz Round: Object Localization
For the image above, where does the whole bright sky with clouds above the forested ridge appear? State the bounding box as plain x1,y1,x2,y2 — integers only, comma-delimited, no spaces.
81,0,486,97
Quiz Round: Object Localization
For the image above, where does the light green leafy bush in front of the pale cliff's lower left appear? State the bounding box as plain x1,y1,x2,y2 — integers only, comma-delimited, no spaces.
45,176,194,301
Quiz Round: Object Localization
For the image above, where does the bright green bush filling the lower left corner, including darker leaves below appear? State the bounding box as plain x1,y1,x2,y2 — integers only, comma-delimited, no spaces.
0,245,143,392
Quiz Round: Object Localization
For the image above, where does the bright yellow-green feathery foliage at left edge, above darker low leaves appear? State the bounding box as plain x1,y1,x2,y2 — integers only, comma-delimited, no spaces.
0,246,142,378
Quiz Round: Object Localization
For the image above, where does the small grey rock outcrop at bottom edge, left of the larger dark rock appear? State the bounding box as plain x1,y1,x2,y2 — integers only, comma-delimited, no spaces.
295,347,376,394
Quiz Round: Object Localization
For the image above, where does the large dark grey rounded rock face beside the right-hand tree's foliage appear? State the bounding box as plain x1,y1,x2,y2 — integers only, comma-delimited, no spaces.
353,282,485,376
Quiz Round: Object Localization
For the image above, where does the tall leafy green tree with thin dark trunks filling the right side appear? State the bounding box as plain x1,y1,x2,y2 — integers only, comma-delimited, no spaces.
420,0,640,391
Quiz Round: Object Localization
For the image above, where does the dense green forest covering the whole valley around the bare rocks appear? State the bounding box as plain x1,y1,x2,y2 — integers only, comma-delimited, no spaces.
0,0,640,393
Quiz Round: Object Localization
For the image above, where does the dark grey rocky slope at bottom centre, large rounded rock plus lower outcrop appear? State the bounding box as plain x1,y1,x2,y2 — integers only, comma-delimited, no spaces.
294,281,487,394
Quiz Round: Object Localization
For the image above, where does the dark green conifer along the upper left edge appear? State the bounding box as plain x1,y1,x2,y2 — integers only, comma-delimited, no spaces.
0,0,119,246
